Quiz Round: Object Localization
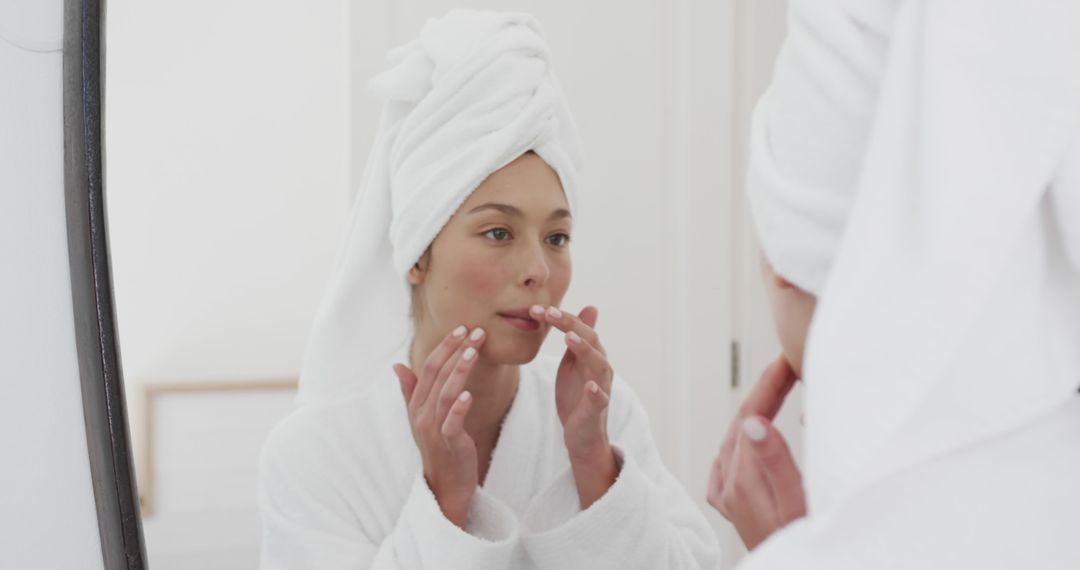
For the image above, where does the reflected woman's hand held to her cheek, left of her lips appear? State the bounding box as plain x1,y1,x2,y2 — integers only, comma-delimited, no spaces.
394,326,487,528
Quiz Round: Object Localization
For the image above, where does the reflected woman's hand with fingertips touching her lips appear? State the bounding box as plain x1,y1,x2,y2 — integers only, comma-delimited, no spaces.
531,306,619,508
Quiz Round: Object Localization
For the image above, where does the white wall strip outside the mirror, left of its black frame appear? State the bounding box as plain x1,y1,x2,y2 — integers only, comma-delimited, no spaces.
0,0,103,569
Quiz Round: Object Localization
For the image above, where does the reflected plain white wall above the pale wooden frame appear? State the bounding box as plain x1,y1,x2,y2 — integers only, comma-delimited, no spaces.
106,0,350,381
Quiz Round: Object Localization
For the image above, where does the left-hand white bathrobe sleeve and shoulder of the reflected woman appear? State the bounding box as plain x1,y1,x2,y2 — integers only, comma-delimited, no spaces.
259,410,518,570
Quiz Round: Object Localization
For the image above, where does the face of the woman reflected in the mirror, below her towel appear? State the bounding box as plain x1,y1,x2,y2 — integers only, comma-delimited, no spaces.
408,152,571,364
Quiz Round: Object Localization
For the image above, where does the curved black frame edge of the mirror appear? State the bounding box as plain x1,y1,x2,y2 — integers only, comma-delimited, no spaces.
63,0,147,570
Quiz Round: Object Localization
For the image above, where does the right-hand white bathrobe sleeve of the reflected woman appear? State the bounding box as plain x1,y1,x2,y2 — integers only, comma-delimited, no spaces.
522,379,719,570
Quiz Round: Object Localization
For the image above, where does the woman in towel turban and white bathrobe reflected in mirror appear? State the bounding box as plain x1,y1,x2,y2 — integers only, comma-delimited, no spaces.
260,11,718,570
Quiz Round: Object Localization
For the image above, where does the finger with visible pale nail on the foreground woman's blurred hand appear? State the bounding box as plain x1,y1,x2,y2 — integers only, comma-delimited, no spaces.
742,416,807,523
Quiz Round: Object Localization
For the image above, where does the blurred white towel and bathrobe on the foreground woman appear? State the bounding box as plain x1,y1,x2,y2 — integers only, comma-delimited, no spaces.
741,0,1080,570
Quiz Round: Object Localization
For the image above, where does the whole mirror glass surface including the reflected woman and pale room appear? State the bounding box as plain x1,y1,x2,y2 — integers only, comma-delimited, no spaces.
106,0,798,568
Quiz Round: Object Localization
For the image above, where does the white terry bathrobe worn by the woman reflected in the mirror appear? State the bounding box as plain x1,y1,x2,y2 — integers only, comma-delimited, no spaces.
259,357,719,570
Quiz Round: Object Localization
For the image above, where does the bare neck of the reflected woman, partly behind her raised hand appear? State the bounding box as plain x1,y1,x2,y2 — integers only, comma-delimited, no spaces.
409,331,521,453
